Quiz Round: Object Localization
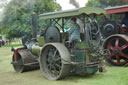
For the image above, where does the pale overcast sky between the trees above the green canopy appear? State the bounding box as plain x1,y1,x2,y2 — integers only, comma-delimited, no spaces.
56,0,88,10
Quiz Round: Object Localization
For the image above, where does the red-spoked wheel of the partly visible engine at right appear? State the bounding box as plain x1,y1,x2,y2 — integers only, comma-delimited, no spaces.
105,36,128,66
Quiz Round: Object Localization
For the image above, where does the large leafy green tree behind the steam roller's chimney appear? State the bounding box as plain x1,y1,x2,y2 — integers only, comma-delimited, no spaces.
0,0,61,39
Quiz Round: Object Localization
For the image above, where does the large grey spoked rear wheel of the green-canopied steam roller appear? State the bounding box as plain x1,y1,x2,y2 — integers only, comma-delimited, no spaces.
40,43,70,80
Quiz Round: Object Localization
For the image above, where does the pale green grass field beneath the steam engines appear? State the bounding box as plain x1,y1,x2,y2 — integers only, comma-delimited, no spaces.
0,46,128,85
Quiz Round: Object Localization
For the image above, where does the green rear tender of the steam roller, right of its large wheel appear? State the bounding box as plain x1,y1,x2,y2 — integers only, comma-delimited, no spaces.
71,50,98,75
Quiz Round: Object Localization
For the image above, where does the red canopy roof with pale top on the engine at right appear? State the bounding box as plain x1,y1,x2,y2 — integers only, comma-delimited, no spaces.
106,5,128,14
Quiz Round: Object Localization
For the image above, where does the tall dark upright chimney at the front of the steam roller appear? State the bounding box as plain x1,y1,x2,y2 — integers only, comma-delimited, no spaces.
31,13,37,41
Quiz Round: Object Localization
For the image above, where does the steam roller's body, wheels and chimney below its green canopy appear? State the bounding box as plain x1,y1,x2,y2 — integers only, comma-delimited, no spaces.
12,6,106,80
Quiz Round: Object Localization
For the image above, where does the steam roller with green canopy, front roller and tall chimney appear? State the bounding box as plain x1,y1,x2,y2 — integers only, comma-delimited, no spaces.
12,7,105,80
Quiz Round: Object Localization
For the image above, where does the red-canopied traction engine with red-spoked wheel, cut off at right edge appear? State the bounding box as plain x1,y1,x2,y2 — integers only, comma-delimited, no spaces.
101,5,128,66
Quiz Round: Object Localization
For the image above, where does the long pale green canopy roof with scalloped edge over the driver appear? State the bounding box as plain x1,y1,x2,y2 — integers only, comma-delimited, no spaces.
39,7,106,19
